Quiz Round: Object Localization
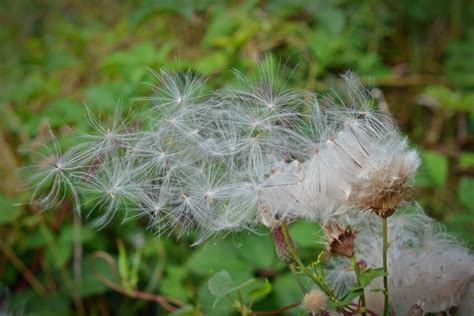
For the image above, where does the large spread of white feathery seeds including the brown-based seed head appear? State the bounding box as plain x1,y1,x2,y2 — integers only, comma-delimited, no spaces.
23,61,418,241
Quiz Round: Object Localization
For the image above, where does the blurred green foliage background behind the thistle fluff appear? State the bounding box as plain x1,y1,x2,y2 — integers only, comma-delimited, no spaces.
0,0,474,315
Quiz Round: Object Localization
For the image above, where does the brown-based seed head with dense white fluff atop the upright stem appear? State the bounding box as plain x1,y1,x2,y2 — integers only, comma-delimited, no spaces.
321,74,419,216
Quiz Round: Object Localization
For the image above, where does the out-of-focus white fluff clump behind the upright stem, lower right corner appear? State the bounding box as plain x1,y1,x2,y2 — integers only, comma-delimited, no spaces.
356,207,474,315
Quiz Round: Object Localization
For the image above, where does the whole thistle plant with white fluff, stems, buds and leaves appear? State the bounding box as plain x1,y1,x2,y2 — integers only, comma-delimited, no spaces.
25,63,474,315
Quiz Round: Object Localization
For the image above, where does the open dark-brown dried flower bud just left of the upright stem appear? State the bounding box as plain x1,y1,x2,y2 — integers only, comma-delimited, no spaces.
324,223,355,258
